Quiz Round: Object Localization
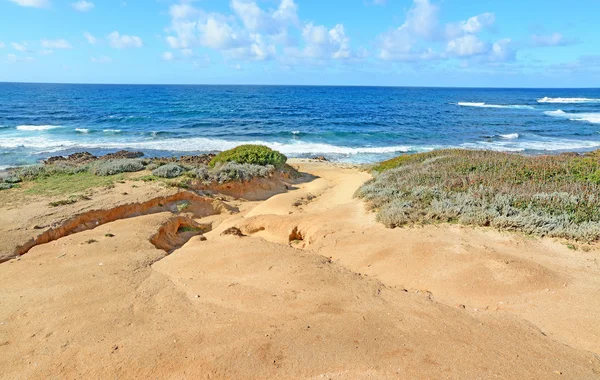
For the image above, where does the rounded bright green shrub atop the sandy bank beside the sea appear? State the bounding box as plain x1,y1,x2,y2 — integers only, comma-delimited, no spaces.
209,145,287,169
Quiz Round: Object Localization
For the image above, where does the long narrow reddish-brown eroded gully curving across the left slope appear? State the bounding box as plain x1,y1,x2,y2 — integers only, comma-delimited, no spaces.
14,191,220,256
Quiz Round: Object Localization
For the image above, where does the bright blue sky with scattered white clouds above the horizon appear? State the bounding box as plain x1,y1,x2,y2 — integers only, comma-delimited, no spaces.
0,0,600,87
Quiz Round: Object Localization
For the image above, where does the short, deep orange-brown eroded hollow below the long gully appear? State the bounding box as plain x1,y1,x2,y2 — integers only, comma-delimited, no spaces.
150,216,212,253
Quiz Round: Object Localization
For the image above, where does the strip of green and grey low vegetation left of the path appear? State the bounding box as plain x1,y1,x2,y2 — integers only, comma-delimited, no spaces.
0,145,293,199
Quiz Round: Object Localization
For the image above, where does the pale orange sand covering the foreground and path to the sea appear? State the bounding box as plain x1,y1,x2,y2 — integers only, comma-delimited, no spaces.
0,161,600,379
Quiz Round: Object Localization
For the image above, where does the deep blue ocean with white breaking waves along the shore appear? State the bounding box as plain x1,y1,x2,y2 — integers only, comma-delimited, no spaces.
0,83,600,167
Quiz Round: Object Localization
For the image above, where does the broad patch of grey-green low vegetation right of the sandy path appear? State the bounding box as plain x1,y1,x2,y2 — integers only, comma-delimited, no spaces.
357,150,600,242
